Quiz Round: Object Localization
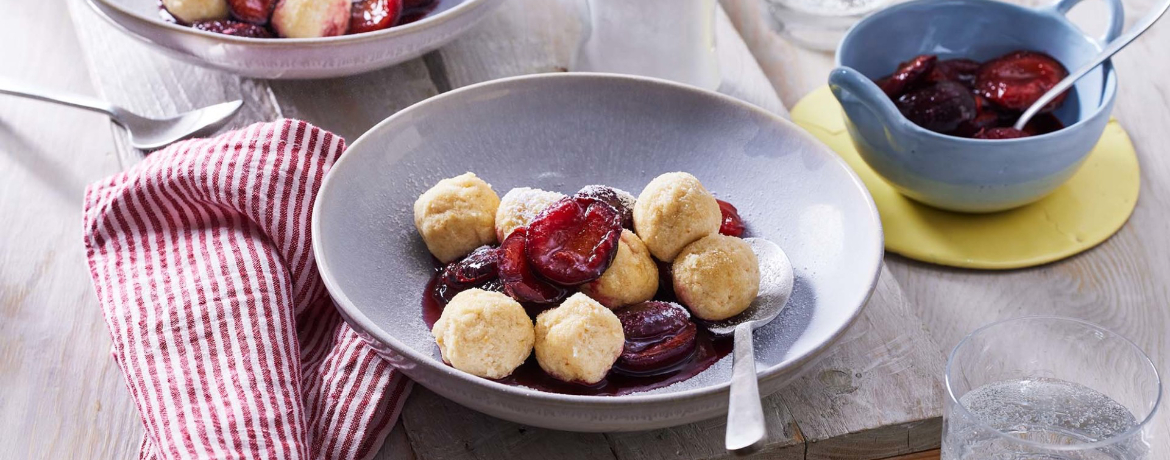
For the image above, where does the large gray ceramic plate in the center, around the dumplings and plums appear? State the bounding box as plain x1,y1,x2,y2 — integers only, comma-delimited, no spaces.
312,74,882,431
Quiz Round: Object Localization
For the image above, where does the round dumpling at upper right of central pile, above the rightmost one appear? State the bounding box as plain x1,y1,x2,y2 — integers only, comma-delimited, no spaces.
634,172,723,262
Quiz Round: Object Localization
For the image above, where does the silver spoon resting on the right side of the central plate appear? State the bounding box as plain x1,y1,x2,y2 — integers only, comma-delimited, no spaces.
707,238,794,454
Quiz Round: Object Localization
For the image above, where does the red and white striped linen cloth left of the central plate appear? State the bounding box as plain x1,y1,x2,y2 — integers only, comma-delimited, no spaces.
84,119,410,459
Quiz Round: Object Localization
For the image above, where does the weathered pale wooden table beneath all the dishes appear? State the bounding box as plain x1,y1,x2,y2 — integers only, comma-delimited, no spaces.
0,0,1170,459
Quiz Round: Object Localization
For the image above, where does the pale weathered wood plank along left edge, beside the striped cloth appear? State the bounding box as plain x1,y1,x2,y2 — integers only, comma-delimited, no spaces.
0,0,140,459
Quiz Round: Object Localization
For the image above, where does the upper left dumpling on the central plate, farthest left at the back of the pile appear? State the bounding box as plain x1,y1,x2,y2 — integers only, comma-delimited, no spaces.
414,170,500,263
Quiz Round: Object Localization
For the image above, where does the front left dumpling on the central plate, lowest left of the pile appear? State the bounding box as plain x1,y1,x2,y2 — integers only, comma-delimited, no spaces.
431,289,535,378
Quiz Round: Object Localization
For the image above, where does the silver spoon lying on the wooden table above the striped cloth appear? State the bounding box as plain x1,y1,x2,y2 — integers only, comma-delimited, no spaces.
0,80,243,150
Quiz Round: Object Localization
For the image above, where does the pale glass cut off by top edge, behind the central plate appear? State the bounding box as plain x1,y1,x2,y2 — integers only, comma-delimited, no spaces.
572,0,721,90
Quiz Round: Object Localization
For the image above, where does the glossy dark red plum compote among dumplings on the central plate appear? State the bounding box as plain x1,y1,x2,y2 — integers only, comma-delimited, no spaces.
422,179,746,396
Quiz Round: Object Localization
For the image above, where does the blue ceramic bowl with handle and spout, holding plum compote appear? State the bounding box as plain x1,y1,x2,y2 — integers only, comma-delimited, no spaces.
828,0,1123,212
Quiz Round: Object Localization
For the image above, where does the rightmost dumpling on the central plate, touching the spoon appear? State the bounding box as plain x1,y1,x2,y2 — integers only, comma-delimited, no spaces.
673,233,759,321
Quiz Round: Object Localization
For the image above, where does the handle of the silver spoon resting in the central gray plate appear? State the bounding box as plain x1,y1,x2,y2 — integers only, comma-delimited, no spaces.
725,322,766,454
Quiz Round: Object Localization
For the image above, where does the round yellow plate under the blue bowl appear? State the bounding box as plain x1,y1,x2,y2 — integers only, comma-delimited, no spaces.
792,87,1140,269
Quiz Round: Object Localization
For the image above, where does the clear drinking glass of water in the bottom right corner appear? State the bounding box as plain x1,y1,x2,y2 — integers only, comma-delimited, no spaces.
942,316,1162,460
